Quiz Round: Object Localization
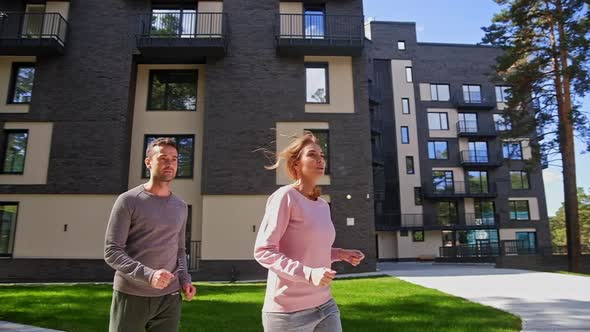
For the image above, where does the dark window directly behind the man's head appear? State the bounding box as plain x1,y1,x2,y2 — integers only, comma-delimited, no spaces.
142,135,195,179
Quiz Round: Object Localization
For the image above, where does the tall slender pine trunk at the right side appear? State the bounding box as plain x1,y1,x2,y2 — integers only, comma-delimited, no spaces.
556,0,582,272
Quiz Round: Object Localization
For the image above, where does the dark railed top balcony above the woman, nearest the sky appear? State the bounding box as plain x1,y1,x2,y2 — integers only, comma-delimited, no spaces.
274,14,365,56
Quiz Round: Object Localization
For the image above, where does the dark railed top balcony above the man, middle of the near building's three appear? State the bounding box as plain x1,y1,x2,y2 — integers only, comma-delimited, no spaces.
136,10,227,60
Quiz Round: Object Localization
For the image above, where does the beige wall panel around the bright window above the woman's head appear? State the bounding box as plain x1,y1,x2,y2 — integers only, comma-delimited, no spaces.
305,56,354,113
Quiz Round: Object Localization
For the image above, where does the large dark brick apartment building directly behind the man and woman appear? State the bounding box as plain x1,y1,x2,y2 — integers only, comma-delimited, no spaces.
0,0,376,281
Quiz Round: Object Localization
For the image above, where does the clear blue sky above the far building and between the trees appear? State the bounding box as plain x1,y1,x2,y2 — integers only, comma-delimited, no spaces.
364,0,590,216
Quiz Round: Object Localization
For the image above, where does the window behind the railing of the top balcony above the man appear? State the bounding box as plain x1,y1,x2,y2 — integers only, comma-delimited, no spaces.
150,8,197,38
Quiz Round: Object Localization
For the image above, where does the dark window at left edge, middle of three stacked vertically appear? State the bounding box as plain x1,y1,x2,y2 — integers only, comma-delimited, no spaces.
2,130,29,174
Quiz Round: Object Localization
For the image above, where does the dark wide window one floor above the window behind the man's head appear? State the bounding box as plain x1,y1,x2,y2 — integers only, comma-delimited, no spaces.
148,70,197,111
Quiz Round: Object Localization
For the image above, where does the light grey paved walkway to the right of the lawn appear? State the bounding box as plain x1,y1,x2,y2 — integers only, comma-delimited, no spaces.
379,263,590,331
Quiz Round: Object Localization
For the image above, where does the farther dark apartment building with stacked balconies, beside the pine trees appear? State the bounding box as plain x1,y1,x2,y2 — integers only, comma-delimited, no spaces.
366,22,551,262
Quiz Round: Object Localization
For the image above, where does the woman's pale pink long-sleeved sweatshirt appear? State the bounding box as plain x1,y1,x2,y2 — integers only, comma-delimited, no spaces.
254,185,340,312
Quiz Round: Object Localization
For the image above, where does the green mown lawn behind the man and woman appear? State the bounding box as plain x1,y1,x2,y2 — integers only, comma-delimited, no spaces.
0,277,521,332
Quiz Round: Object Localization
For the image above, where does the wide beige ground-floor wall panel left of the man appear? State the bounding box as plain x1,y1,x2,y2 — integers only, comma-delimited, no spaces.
0,195,117,259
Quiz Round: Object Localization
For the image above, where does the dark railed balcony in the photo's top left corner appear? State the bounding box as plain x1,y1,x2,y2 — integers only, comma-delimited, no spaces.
0,12,68,56
